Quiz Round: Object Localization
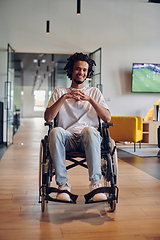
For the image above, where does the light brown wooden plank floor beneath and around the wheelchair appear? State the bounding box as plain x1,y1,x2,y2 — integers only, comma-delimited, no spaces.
0,118,160,240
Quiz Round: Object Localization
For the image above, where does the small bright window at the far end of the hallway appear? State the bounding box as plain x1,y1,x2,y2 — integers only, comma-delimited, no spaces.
34,90,46,112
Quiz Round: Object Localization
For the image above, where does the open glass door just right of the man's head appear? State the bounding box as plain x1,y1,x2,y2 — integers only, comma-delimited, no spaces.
89,48,103,92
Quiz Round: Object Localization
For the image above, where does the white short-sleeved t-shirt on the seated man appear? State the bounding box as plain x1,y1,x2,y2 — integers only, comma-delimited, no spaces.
47,87,109,133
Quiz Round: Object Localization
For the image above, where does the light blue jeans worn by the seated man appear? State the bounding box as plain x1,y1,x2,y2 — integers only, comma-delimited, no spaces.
49,127,102,185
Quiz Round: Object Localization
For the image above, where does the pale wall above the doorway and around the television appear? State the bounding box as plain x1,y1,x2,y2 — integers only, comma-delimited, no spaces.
0,0,160,122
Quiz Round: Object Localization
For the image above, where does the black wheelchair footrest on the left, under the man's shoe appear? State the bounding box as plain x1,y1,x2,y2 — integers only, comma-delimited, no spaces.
45,187,78,204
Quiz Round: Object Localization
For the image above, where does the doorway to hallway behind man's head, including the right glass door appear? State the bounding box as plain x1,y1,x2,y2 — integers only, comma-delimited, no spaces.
14,48,103,118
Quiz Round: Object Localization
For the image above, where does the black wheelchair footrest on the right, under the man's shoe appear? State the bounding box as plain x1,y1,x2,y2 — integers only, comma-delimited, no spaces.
84,187,117,204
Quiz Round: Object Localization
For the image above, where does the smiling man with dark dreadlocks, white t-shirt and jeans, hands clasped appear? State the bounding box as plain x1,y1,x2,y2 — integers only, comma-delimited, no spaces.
44,52,111,202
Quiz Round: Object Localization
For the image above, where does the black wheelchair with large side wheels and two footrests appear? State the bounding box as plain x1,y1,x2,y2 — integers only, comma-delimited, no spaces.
39,118,119,212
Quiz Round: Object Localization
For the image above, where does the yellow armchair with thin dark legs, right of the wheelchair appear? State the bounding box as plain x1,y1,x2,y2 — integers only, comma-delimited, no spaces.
109,116,143,151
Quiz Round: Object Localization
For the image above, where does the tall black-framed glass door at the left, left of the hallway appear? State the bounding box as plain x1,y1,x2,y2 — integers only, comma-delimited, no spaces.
5,44,15,146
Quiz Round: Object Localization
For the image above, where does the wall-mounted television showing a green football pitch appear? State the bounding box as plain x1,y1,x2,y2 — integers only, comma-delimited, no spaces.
131,63,160,93
